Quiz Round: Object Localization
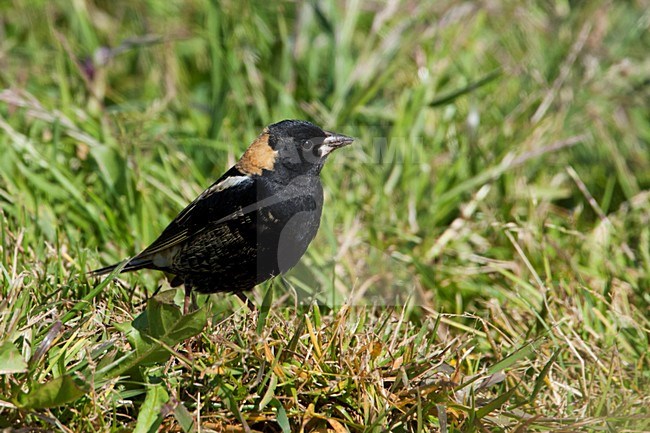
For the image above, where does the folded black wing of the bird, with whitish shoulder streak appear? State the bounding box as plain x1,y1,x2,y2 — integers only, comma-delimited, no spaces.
133,167,257,260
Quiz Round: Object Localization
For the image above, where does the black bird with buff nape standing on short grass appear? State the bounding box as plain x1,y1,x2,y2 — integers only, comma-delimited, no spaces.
90,120,354,314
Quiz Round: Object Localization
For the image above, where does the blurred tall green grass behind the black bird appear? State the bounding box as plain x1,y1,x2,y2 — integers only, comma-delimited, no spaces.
0,0,650,427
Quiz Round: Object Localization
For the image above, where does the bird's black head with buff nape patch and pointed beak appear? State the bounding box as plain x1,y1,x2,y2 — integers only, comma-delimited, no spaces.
237,120,354,175
